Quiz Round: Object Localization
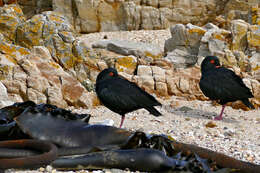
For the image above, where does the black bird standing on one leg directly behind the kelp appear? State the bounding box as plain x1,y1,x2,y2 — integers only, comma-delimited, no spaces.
96,68,162,128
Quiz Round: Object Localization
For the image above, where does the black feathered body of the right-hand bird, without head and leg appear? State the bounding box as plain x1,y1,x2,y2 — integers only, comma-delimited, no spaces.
199,68,252,100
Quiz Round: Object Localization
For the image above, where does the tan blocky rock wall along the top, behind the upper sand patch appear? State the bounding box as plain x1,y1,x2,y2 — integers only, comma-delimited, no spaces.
0,0,254,33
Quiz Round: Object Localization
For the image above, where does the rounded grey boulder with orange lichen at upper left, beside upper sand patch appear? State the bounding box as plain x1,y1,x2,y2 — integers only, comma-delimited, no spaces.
16,11,77,69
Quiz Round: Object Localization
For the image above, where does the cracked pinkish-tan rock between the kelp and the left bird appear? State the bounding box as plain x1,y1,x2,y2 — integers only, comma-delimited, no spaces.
16,47,91,108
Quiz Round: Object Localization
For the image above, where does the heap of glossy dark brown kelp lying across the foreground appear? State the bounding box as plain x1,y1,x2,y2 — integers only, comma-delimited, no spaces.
0,102,260,173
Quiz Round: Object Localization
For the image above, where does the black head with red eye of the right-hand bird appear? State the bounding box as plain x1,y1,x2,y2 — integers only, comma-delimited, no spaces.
201,56,220,73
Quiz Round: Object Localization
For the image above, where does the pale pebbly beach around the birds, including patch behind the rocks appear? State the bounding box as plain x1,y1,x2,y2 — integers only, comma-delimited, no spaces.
7,29,260,173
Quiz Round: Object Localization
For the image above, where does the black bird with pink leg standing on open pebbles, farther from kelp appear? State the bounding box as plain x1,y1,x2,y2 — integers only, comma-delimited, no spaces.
199,56,254,120
